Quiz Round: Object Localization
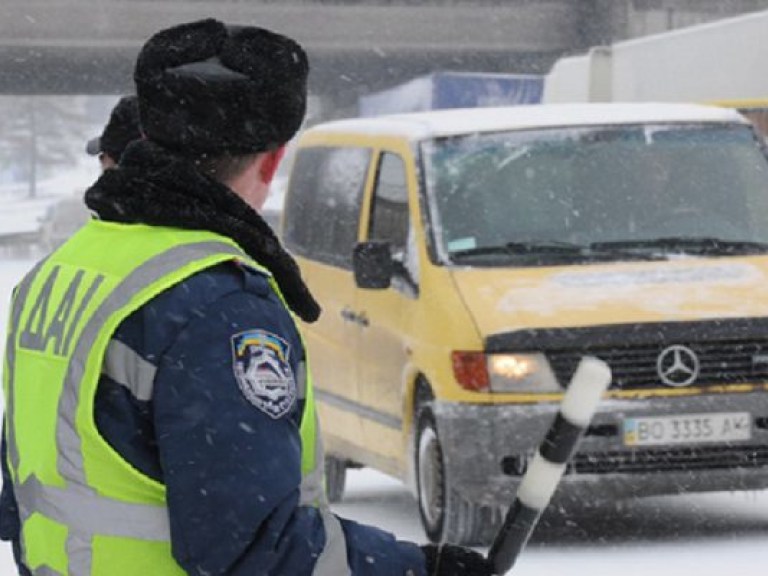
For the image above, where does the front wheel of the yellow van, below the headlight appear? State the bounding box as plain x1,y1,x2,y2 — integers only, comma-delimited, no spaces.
415,408,500,546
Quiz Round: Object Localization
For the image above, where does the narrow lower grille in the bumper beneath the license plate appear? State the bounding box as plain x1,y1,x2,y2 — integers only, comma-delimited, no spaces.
567,445,768,474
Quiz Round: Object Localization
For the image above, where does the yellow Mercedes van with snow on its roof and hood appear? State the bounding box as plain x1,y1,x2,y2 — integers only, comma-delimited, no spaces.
282,103,768,543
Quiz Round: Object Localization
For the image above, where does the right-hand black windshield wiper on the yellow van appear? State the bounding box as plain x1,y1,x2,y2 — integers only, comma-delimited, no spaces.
590,236,768,254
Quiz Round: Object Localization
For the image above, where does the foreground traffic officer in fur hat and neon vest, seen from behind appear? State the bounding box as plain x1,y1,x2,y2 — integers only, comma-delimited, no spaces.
0,19,491,576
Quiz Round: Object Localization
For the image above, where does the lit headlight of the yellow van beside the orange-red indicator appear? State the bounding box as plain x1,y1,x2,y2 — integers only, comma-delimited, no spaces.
486,354,562,392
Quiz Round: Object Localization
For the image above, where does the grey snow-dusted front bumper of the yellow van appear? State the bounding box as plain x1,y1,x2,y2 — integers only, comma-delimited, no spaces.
434,392,768,505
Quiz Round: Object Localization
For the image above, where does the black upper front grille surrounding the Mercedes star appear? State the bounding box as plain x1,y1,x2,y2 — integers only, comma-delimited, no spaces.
546,334,768,390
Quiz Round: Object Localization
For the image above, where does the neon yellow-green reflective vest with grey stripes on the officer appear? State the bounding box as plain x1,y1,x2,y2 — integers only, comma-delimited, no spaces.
3,220,323,576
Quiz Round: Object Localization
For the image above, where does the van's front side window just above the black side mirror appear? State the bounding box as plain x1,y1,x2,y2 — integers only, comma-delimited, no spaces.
368,152,418,288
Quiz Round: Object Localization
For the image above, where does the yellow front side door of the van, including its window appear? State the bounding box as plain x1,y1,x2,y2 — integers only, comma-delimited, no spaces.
356,152,418,476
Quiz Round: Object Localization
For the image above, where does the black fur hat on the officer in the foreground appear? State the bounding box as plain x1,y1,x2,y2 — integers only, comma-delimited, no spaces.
134,19,309,156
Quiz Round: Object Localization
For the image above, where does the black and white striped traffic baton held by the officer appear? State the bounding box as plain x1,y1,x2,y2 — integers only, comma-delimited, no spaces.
488,356,611,574
